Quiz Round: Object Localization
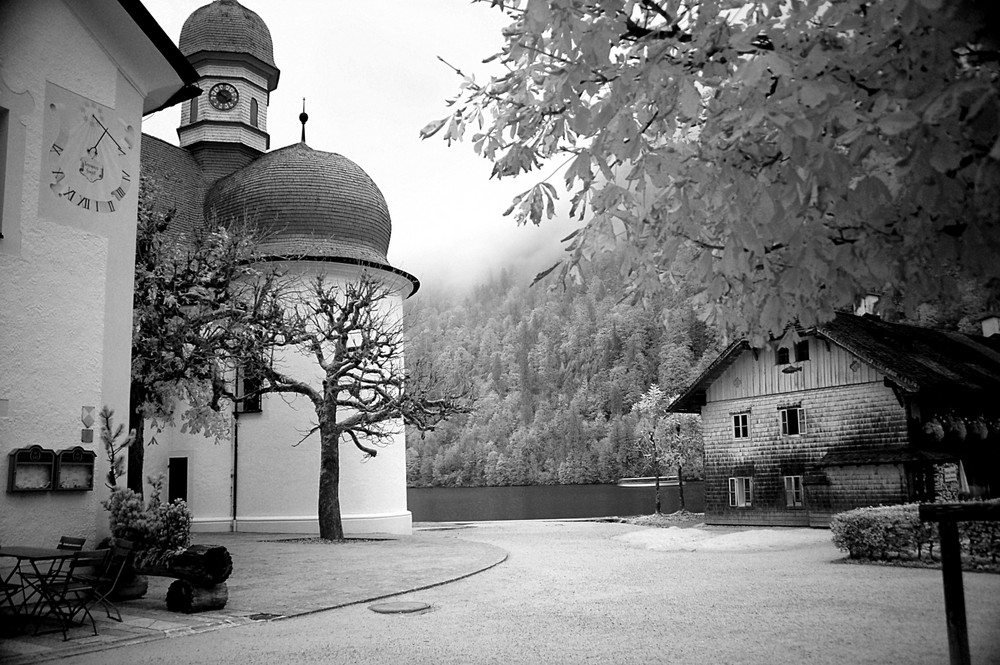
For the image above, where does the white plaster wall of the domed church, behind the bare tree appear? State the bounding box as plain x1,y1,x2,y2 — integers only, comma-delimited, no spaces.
145,263,412,534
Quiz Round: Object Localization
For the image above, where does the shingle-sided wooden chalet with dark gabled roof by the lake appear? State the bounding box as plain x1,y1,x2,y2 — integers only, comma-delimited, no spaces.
670,314,1000,526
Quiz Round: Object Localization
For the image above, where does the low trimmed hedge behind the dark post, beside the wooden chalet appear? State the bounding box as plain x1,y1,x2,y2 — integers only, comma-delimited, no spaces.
830,501,1000,564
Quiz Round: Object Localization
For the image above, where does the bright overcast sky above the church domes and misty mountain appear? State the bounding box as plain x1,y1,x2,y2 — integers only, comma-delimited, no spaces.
143,0,573,290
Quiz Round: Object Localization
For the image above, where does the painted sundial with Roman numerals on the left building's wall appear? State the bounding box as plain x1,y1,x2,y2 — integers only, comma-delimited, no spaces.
47,95,137,213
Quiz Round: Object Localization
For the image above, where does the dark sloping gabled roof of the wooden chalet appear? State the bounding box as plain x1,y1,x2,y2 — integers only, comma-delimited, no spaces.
670,313,1000,413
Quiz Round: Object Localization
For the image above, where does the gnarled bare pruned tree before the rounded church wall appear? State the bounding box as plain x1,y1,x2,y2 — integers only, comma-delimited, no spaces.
238,272,468,540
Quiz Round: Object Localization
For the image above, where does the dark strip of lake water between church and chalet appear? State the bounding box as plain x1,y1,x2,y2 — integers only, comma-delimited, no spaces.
406,481,705,522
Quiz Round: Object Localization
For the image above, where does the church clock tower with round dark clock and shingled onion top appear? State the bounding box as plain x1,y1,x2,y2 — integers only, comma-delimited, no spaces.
177,0,280,182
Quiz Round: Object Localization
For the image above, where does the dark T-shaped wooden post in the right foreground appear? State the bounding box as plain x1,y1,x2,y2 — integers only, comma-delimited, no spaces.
920,503,1000,665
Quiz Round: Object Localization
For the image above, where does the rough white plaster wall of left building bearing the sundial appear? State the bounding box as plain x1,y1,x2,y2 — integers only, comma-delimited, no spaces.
0,0,143,545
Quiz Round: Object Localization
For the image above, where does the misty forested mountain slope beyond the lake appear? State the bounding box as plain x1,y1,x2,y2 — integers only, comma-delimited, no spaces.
406,254,720,486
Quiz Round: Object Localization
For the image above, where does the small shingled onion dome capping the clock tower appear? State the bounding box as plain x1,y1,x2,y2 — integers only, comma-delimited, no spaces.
178,0,278,90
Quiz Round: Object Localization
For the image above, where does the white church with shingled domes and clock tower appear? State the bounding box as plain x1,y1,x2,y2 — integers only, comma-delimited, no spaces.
141,0,419,534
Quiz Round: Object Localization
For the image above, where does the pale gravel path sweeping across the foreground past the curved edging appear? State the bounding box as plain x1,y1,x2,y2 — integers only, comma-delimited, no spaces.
27,522,1000,665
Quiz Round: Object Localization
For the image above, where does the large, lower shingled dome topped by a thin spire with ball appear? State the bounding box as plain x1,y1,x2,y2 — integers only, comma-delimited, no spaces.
205,143,392,267
